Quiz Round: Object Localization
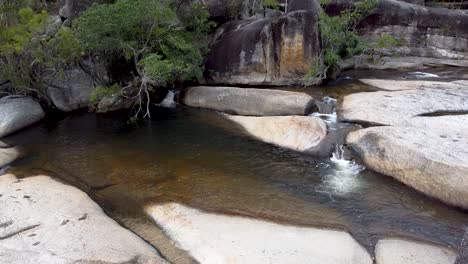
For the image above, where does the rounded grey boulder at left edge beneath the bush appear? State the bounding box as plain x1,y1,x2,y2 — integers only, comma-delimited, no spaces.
0,97,45,137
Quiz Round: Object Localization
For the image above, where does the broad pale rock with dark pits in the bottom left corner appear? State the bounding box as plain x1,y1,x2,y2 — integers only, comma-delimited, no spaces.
0,175,166,264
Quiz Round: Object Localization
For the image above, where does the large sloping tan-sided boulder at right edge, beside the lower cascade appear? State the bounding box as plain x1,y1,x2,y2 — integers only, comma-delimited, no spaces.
346,127,468,209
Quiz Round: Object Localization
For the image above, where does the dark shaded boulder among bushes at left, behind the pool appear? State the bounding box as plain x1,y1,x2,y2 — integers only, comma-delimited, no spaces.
47,68,95,112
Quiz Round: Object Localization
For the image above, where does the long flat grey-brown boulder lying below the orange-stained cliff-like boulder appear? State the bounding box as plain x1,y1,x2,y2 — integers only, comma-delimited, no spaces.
182,86,315,116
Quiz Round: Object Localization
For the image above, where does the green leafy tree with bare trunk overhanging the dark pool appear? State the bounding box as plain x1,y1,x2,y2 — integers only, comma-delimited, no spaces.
74,0,212,117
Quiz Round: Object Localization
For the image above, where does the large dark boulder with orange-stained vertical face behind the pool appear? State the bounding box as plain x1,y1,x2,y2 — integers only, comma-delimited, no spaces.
205,5,320,85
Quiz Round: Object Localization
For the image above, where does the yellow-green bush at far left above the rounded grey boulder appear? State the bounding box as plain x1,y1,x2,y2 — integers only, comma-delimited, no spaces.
0,7,82,98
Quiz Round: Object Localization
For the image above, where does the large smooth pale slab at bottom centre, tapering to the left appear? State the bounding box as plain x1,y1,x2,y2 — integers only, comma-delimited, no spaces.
145,203,372,264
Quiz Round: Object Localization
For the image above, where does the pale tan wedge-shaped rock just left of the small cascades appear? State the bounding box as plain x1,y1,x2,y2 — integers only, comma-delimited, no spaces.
227,115,327,151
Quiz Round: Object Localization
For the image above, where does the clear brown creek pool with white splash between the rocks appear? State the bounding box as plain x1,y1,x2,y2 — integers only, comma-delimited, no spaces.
2,72,468,263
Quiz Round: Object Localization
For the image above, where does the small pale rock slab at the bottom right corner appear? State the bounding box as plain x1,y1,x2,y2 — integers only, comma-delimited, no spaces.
375,239,457,264
